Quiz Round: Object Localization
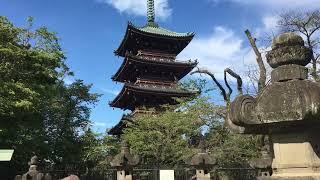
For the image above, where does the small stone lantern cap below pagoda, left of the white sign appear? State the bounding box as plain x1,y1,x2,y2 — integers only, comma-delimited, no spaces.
110,142,139,169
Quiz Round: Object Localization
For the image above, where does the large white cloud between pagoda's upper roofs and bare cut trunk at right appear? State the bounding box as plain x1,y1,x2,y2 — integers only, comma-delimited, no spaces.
179,26,255,79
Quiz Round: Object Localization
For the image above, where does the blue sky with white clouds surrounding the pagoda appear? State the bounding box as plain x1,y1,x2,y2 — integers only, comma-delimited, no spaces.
0,0,320,132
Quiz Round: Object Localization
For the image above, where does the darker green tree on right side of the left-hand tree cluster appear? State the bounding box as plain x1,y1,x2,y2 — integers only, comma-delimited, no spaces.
41,80,98,166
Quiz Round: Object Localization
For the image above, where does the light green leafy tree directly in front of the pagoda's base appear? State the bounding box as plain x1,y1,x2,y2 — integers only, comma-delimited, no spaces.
123,97,203,167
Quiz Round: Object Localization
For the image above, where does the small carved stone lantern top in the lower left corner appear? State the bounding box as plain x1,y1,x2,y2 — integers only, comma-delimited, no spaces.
15,156,52,180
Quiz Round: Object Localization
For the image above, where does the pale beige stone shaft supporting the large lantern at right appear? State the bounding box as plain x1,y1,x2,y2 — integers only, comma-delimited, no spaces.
272,131,320,179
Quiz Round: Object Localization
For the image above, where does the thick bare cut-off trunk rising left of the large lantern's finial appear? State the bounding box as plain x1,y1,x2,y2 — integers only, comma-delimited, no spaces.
245,29,267,92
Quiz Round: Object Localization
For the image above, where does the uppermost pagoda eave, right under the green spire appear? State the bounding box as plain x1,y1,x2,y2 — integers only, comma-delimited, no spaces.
114,22,195,57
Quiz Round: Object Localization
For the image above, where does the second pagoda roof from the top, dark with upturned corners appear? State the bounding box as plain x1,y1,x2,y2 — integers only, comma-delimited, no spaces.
112,54,198,82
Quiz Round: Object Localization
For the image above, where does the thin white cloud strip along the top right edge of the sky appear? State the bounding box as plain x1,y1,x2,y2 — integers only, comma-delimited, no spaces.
211,0,320,9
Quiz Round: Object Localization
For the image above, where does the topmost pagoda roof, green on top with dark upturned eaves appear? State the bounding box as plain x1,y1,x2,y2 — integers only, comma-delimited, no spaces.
115,22,194,57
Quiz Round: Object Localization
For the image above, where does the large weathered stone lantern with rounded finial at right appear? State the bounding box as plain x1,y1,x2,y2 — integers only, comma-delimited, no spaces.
228,33,320,180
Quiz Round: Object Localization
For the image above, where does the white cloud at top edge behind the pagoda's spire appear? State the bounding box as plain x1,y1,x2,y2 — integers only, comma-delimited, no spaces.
99,0,172,20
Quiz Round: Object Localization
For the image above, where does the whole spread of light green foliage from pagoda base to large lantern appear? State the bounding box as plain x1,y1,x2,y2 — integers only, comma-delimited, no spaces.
123,93,258,167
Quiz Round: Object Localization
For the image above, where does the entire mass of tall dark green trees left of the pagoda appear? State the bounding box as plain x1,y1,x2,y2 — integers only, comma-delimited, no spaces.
0,17,99,175
